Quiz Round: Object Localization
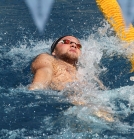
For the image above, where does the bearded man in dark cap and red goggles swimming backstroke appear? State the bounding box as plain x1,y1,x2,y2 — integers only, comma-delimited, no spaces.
29,36,82,90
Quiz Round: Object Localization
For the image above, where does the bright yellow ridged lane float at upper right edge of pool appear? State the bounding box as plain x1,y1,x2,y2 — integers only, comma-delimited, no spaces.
96,0,134,72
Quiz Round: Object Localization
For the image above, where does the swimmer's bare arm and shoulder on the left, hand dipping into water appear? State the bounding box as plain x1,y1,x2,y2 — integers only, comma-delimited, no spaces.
29,54,53,90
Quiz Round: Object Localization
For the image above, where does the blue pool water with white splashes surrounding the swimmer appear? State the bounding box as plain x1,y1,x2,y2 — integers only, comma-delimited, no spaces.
0,0,134,139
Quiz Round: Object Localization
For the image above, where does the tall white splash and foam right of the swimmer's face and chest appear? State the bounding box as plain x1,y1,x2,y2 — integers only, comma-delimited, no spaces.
60,23,134,133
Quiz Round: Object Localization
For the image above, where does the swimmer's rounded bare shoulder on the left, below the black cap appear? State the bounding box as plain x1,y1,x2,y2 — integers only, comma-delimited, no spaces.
31,53,54,72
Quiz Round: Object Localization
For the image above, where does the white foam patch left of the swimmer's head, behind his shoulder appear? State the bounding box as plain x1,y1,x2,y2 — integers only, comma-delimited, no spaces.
4,40,52,68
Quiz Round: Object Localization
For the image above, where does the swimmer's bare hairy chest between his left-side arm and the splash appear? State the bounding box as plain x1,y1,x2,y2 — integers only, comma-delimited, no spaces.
50,59,76,90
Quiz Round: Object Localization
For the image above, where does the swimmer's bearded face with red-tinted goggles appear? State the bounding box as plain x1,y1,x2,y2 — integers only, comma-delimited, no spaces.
52,36,81,60
